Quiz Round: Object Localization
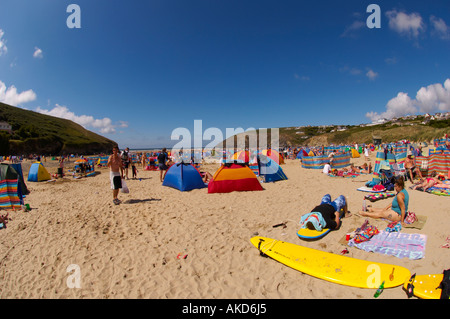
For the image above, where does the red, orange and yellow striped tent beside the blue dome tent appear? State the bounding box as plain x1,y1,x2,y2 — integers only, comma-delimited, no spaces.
208,163,263,193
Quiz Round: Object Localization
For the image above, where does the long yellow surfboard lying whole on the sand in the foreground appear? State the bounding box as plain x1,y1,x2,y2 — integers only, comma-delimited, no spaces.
250,236,411,289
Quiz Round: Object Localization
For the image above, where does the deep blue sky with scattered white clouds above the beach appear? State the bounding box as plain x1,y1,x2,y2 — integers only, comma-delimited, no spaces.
0,0,450,148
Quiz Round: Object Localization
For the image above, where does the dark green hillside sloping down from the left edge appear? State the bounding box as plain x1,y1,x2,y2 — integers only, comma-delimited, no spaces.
0,103,117,155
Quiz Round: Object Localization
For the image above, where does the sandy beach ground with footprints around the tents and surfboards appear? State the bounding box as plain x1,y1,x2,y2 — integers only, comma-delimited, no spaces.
0,152,450,299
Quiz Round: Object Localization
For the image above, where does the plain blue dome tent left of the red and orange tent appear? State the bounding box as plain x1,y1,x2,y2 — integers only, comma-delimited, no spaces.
163,163,207,192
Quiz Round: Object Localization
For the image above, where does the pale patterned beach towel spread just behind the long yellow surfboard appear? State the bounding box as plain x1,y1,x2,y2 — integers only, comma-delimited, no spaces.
348,230,427,260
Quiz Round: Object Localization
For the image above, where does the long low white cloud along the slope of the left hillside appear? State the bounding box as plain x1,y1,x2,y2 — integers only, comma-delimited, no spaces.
36,104,128,134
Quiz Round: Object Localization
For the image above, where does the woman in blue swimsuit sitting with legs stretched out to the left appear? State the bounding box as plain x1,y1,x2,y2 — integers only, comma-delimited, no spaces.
359,176,409,224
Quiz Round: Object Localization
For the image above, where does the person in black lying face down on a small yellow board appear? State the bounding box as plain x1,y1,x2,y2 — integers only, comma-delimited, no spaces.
300,194,349,231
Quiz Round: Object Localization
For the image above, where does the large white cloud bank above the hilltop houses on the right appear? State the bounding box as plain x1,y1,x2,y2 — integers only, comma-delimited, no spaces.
366,79,450,121
